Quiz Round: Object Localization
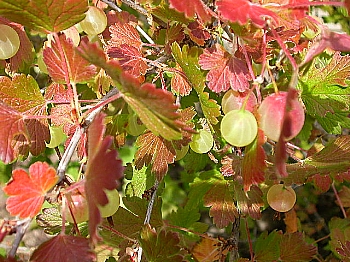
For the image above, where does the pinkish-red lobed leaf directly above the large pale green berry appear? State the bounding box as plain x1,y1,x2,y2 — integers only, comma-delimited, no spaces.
199,44,251,93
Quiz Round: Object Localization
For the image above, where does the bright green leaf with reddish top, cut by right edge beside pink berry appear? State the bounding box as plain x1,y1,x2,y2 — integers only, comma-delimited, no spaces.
299,53,350,134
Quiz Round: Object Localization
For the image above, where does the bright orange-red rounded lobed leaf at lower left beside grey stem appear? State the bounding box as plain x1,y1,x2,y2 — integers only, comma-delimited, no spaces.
4,162,58,218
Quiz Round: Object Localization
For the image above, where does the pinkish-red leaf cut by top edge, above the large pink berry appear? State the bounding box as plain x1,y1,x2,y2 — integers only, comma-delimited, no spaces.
216,0,277,27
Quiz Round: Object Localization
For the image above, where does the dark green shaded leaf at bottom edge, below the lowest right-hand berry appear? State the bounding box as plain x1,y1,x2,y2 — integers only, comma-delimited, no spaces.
254,231,282,262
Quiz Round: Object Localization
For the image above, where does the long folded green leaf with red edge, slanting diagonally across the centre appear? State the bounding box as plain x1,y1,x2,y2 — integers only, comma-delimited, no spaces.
79,42,184,140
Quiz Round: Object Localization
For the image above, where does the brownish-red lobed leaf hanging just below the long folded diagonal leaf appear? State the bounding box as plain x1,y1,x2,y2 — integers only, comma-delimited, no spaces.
135,132,176,181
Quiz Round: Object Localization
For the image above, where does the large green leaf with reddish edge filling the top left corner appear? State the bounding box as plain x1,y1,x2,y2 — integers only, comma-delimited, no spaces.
0,0,87,33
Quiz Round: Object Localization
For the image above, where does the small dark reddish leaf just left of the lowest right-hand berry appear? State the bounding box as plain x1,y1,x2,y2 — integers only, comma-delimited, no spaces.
234,183,264,219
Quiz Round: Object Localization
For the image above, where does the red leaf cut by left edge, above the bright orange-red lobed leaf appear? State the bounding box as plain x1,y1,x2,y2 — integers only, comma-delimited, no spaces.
0,102,29,164
